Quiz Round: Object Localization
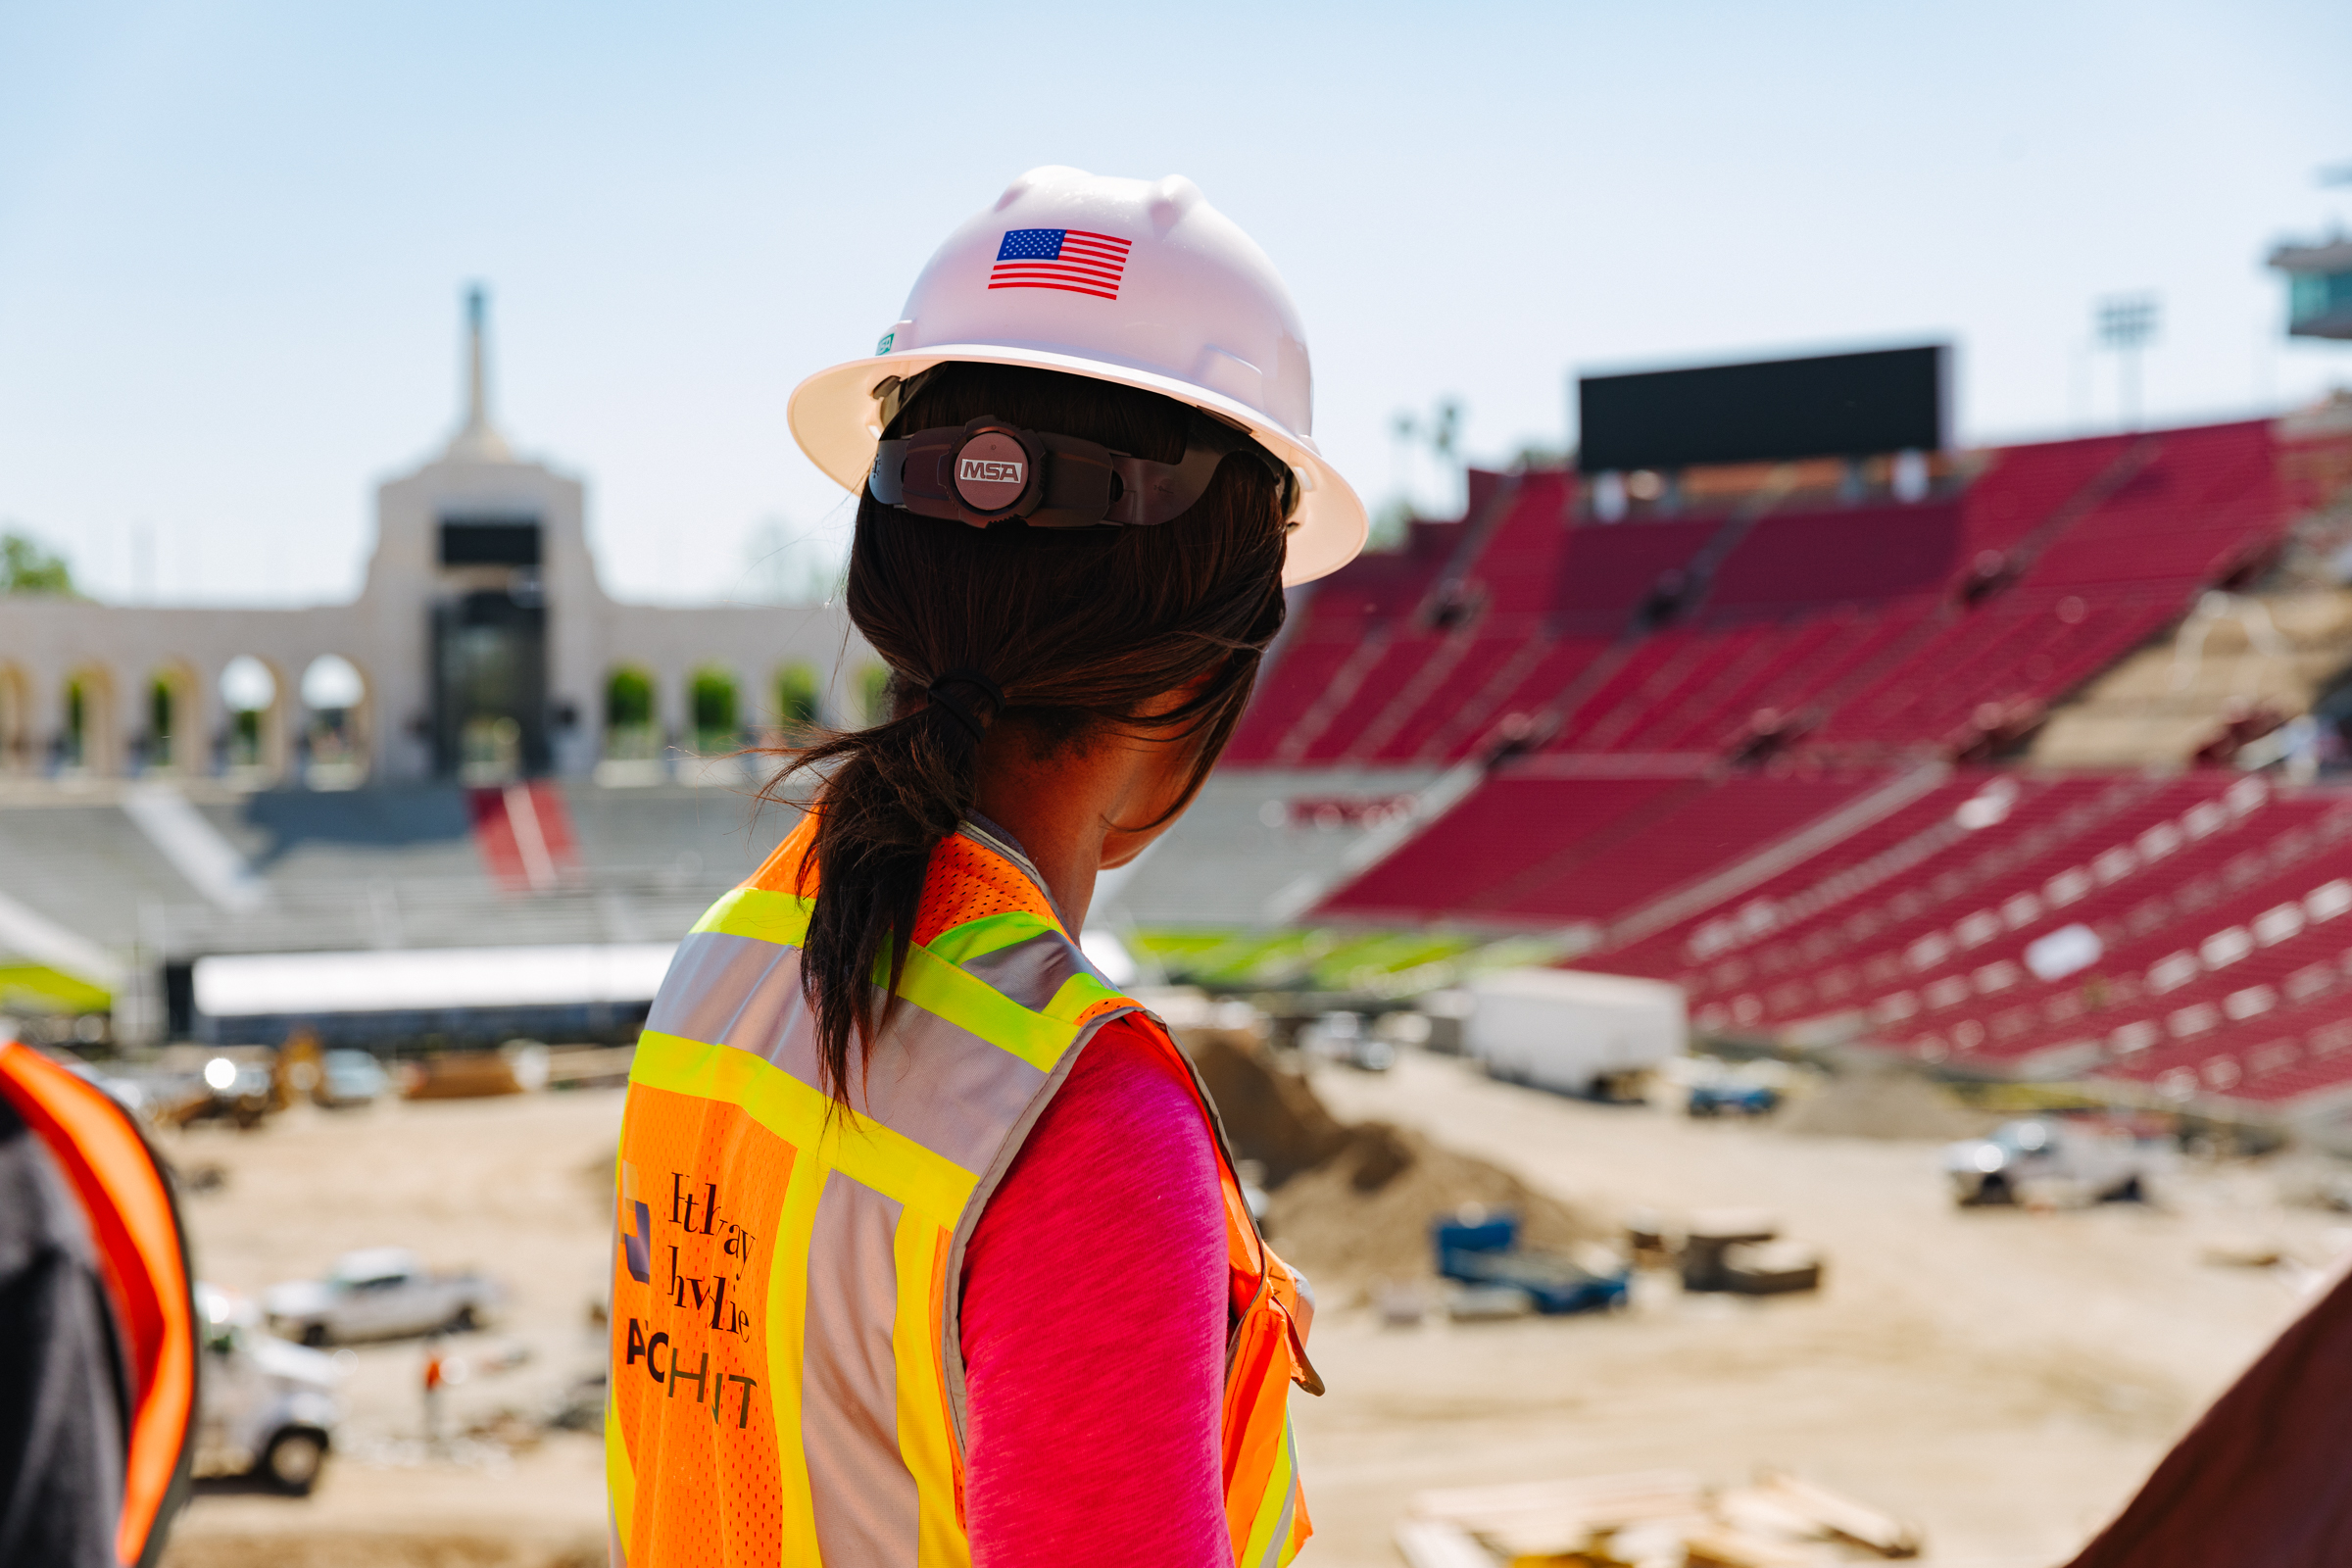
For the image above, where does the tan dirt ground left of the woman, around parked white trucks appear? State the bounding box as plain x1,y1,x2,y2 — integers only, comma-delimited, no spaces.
165,1091,621,1568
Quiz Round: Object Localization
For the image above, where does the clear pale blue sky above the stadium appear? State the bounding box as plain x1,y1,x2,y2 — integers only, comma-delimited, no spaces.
0,0,2352,602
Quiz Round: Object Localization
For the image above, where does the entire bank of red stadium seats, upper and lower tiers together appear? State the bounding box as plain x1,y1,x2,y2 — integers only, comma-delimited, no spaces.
1233,423,2352,1128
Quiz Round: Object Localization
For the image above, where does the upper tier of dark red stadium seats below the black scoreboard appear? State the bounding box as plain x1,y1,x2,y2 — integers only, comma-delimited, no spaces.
1230,423,2293,766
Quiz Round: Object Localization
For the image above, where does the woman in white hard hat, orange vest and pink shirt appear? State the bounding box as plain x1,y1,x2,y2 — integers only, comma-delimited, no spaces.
605,170,1364,1568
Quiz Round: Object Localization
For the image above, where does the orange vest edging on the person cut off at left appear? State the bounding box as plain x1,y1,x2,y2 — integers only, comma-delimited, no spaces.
0,1039,195,1568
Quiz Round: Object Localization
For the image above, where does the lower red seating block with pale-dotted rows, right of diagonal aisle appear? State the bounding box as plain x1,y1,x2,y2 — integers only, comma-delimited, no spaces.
1586,768,2352,1101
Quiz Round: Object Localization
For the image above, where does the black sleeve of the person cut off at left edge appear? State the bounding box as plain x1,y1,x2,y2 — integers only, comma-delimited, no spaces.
0,1098,127,1568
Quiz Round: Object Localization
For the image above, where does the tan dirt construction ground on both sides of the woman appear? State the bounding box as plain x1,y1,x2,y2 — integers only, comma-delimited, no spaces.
167,1054,2352,1568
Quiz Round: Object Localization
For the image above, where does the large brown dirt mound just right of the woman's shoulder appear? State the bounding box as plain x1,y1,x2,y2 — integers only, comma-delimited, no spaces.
1181,1030,1604,1281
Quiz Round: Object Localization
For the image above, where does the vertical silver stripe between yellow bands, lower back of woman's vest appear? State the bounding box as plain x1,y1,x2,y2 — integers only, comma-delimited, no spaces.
800,1171,919,1568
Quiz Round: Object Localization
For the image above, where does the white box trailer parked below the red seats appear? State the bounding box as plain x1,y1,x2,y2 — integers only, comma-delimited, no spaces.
1463,968,1691,1098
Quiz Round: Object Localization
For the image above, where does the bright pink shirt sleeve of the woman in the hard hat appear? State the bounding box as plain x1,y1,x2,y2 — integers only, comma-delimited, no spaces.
962,1020,1233,1568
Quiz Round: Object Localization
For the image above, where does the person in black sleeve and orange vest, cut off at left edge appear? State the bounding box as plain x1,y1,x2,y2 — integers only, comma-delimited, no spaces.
0,1039,195,1568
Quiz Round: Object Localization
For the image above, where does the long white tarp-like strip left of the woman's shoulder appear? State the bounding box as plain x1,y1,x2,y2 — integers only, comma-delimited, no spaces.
195,943,677,1018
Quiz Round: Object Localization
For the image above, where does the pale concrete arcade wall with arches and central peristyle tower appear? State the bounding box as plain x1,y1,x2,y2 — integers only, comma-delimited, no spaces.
0,442,877,780
